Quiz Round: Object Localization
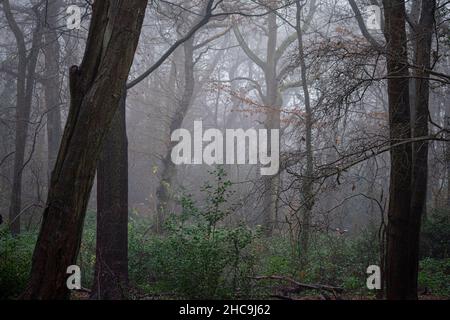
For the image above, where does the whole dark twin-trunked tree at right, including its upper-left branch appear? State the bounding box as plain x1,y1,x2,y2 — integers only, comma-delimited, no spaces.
349,0,436,299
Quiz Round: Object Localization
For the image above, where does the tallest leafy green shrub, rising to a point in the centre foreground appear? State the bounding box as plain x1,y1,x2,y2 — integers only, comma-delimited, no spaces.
133,168,255,299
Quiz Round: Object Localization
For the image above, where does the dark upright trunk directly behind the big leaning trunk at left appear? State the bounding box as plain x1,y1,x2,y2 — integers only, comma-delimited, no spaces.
91,94,128,300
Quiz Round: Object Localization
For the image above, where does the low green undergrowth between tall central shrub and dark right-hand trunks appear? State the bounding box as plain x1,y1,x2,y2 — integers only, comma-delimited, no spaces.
251,228,379,293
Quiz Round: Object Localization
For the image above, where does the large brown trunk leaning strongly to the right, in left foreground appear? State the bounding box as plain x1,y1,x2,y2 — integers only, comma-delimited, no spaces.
22,0,147,299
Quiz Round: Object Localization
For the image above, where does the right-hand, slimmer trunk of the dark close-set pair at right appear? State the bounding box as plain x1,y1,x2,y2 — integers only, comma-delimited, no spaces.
404,0,436,299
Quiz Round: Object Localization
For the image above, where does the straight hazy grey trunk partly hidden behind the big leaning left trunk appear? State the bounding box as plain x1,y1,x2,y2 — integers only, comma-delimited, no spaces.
43,0,62,177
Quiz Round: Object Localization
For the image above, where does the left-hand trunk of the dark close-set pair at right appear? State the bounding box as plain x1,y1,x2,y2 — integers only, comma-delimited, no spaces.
383,0,414,299
